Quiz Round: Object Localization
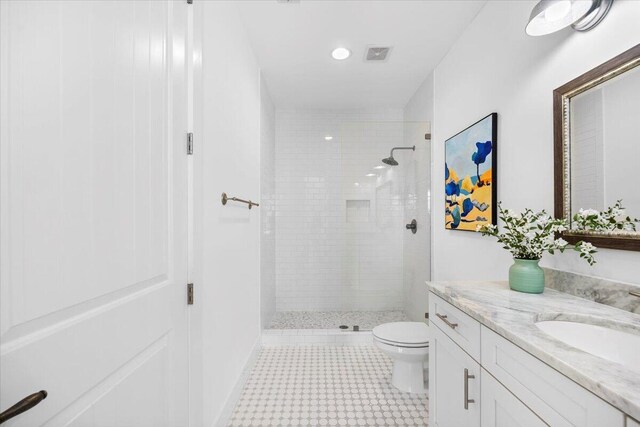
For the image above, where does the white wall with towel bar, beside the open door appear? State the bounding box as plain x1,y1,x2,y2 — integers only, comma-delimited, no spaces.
191,2,261,426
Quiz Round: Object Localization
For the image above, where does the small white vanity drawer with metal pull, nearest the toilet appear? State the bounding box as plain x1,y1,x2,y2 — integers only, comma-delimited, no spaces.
429,293,480,362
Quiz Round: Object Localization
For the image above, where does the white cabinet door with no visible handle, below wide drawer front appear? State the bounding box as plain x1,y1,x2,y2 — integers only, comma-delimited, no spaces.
480,369,547,427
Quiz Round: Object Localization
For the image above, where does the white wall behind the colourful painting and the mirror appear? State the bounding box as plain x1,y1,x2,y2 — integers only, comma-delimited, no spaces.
427,0,640,283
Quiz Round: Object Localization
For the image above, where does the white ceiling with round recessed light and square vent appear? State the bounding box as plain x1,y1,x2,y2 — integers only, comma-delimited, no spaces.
237,0,486,109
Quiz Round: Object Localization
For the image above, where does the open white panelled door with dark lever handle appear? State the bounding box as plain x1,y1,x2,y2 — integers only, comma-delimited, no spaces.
0,0,189,427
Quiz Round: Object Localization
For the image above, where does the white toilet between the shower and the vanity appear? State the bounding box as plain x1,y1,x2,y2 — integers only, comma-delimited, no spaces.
373,322,429,393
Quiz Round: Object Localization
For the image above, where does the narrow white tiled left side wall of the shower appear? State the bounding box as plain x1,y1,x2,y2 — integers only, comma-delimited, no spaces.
260,79,276,328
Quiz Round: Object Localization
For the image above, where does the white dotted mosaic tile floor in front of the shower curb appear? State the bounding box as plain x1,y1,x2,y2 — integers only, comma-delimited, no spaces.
229,346,428,426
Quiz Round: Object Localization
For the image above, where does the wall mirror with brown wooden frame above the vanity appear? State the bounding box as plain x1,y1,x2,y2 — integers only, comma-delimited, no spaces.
553,44,640,251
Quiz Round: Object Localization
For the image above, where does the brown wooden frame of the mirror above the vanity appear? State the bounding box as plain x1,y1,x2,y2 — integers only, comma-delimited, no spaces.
553,44,640,251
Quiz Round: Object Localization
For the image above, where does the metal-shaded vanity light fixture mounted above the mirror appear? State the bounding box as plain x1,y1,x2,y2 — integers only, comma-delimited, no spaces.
526,0,613,36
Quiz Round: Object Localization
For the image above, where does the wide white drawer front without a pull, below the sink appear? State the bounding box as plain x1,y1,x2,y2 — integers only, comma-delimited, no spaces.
481,326,624,427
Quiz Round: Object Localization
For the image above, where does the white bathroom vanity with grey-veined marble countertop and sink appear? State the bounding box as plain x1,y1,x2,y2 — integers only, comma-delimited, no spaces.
427,282,640,427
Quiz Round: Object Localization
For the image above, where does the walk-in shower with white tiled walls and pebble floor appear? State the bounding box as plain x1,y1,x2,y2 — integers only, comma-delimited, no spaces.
265,111,431,342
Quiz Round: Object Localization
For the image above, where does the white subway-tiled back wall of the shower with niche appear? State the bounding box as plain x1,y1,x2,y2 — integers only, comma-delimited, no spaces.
276,110,404,311
